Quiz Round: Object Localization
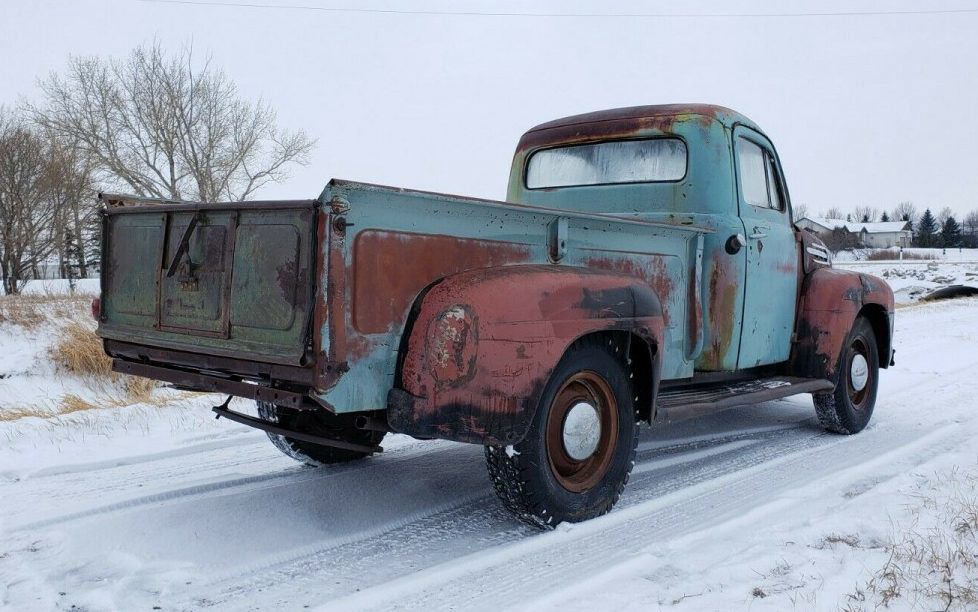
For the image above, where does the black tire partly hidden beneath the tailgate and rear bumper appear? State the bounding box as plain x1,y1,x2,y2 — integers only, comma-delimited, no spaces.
256,401,384,466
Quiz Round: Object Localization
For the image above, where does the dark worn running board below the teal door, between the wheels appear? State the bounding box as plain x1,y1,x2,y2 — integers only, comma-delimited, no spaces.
655,376,835,422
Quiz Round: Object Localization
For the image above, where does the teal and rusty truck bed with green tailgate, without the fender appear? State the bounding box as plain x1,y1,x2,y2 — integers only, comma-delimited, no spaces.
99,180,709,413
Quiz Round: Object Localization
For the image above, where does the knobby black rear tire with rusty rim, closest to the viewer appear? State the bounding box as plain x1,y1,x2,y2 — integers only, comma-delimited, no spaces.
486,337,638,529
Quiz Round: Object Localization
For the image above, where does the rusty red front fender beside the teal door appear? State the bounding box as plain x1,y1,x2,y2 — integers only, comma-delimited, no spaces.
791,268,894,380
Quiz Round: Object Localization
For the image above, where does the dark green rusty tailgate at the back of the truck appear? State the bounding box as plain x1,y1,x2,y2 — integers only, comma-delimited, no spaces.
99,196,318,365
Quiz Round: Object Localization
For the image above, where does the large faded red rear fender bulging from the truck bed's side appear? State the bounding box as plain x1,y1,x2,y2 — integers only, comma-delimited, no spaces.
388,265,663,444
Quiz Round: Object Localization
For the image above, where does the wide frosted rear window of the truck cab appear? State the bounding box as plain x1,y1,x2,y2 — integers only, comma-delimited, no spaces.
526,138,686,189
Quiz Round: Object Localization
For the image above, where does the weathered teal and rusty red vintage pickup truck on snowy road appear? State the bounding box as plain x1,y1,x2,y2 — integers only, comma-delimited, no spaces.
93,105,894,527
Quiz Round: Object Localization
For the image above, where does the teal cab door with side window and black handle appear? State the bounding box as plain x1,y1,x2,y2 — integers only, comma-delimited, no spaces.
734,126,799,369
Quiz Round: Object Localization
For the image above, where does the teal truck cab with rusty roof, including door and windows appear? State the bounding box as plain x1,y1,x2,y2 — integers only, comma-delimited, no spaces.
507,105,802,372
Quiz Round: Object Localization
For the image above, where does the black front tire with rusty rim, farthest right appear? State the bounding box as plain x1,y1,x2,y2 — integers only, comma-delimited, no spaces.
812,317,879,434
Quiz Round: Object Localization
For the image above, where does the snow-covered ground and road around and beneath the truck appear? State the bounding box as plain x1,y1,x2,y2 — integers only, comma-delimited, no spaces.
0,274,978,611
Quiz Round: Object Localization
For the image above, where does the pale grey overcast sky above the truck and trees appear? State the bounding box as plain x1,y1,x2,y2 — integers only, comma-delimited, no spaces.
0,0,978,219
